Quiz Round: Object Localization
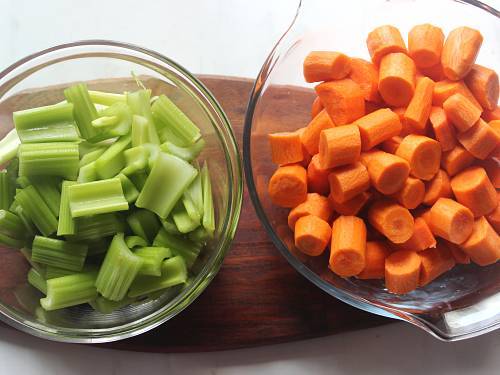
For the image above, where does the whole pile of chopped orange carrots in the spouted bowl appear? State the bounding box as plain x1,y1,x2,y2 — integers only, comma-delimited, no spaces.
268,24,500,294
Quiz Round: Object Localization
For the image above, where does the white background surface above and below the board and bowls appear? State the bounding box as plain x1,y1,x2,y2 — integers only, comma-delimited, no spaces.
0,0,500,375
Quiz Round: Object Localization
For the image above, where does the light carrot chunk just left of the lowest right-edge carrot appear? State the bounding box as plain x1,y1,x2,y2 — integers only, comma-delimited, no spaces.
430,198,474,244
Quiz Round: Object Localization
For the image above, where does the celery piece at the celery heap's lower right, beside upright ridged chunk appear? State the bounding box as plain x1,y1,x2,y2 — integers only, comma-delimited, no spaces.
128,256,187,298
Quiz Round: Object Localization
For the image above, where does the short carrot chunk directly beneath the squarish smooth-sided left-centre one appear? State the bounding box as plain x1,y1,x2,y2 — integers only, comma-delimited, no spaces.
328,162,370,203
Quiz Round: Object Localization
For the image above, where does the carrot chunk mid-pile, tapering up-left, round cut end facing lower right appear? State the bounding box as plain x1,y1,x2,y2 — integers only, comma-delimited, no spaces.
361,150,410,194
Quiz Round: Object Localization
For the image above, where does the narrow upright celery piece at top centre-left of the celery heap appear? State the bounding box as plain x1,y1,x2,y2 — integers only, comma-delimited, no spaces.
64,83,98,139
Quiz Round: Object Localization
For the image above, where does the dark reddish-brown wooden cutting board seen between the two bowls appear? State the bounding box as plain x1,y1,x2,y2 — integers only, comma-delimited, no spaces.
94,76,391,353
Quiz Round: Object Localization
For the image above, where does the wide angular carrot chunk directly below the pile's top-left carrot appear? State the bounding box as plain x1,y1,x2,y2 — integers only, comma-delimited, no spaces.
315,79,365,125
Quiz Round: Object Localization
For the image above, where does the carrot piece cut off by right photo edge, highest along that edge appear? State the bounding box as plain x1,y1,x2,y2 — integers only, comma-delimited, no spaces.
465,64,499,111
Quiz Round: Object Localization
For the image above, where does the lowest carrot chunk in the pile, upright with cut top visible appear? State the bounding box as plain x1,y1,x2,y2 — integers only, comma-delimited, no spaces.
385,250,421,294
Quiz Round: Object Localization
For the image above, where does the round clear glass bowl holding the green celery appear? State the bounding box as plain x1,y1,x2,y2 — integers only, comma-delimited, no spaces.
0,41,243,343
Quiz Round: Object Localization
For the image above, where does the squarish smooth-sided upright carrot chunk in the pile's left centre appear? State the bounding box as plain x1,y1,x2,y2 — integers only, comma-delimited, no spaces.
319,125,361,169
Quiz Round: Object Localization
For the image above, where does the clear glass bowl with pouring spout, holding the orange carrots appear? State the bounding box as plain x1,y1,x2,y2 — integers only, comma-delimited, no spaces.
244,0,500,341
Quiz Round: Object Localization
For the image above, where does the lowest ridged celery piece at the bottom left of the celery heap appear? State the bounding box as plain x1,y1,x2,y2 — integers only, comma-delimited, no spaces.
40,271,97,311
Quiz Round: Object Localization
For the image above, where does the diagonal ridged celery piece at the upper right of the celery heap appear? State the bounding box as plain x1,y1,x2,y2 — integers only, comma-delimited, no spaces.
151,95,201,147
